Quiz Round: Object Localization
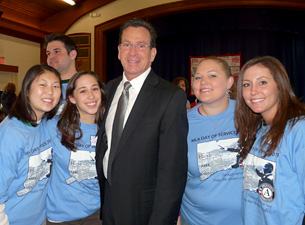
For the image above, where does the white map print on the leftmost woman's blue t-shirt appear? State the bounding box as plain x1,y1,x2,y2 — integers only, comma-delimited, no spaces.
17,147,52,197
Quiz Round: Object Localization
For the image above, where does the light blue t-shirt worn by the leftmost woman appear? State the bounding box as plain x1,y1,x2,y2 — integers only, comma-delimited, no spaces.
0,117,52,225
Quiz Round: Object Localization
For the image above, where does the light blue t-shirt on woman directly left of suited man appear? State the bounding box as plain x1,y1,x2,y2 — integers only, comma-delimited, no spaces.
47,117,101,222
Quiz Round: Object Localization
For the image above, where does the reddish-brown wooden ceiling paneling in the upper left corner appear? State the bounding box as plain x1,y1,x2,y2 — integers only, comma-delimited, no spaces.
0,0,115,43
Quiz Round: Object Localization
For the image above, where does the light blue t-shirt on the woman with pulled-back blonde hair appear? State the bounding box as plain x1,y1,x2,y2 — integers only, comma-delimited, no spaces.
181,100,243,225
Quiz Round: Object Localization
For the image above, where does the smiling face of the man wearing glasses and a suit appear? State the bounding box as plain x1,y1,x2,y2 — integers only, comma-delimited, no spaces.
118,27,157,80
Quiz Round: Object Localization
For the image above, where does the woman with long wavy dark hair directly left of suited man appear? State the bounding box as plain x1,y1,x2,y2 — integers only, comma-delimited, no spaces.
47,71,106,225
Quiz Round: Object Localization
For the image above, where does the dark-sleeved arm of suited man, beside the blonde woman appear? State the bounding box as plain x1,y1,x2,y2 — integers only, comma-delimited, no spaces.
149,90,188,225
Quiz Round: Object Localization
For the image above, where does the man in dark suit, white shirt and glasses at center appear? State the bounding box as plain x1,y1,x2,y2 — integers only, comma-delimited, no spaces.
96,18,188,225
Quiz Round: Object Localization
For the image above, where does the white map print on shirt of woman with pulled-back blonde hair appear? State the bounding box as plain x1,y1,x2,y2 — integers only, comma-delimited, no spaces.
197,138,241,181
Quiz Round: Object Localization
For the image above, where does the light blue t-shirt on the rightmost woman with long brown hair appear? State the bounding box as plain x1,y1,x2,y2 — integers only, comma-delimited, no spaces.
242,120,305,225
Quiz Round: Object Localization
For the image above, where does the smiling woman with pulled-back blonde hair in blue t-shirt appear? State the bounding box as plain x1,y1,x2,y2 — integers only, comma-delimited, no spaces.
181,56,243,225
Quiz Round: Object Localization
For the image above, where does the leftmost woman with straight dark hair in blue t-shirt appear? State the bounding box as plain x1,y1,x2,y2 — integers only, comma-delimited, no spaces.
0,65,61,225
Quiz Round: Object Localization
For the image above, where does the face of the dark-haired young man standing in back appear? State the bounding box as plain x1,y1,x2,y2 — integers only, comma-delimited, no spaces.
46,41,76,74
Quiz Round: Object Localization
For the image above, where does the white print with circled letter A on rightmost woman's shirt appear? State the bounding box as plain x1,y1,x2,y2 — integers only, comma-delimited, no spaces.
243,154,276,202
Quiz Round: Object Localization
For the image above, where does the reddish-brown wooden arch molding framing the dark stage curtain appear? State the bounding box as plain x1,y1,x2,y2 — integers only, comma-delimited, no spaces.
94,0,305,83
